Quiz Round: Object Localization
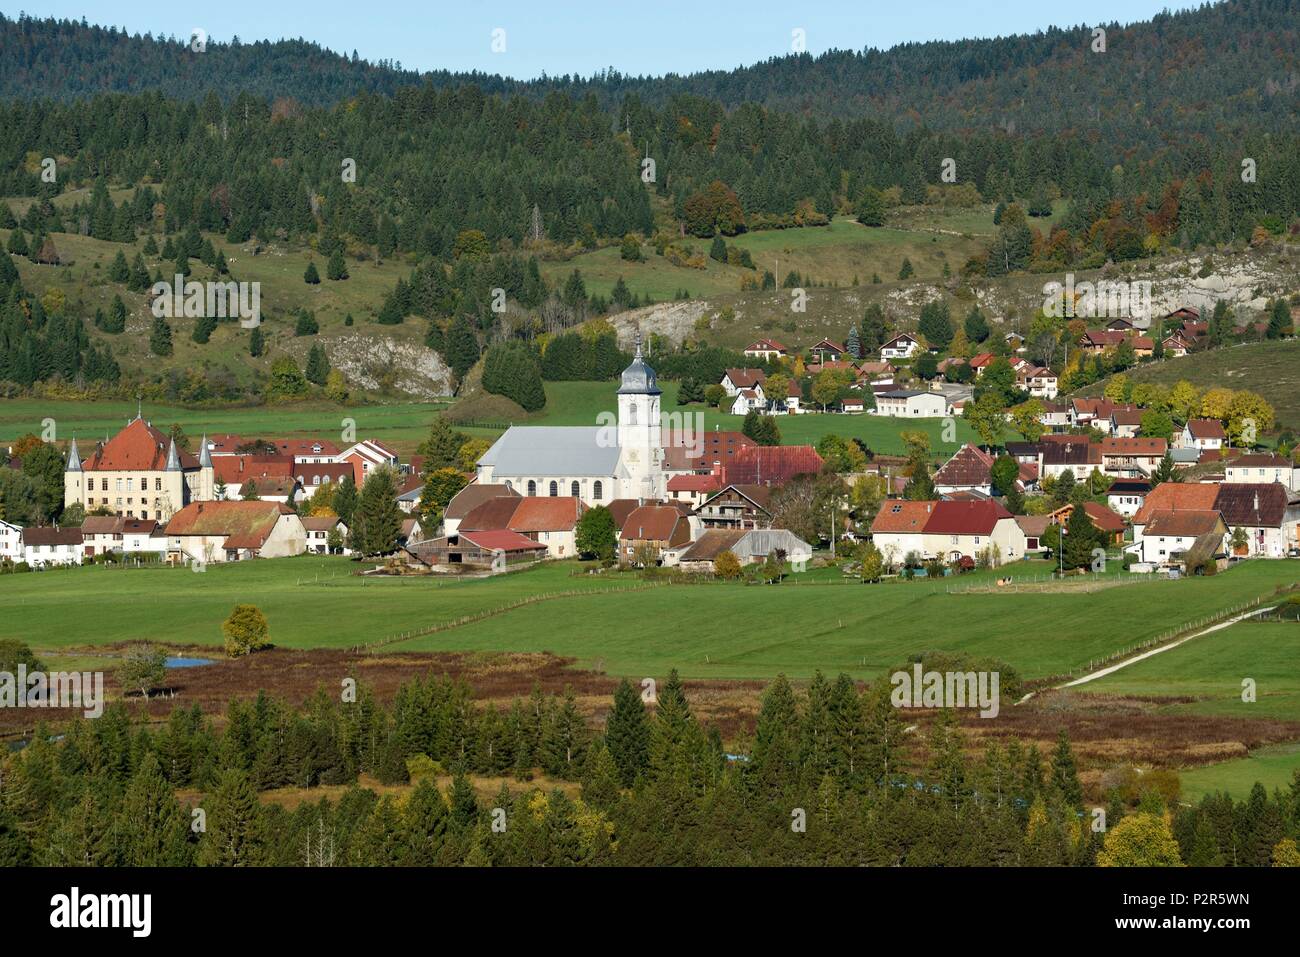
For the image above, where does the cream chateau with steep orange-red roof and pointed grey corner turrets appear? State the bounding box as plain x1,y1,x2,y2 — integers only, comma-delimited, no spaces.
64,415,216,521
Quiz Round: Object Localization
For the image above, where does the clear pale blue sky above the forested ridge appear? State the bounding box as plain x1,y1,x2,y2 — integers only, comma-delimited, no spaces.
12,0,1195,79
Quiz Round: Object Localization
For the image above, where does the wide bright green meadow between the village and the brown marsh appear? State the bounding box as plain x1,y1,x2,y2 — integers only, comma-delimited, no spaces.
0,557,1296,679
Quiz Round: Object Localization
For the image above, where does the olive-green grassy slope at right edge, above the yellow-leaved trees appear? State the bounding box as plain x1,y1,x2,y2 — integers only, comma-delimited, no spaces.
1084,339,1300,428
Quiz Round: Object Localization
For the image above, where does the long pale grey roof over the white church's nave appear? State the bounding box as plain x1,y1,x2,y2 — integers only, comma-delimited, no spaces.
478,425,619,481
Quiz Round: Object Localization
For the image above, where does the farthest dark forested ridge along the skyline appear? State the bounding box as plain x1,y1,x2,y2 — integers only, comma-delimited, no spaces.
0,0,1300,148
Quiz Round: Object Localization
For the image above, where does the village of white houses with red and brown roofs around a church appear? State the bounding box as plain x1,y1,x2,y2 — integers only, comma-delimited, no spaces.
0,302,1300,577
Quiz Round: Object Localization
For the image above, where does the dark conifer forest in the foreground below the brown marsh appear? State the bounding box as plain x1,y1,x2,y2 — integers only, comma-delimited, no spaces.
0,672,1300,867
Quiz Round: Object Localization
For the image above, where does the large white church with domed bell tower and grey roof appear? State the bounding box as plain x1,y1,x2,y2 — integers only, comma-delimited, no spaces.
477,335,667,506
